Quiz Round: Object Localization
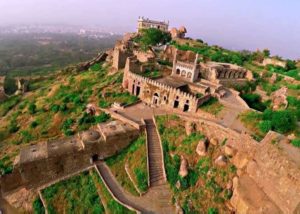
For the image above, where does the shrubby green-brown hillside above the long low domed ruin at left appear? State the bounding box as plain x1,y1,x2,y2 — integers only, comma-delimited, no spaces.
0,64,137,173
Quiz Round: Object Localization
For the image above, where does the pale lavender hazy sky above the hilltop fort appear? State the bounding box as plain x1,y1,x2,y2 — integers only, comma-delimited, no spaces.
0,0,300,58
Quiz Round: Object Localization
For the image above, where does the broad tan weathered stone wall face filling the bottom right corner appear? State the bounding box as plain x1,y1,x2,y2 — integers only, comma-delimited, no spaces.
247,132,300,213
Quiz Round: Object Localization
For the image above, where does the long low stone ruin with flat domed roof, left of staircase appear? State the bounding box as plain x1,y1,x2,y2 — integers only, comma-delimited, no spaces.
0,121,139,193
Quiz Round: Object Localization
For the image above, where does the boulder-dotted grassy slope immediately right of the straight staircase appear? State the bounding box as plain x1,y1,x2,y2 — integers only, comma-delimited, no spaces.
156,115,236,213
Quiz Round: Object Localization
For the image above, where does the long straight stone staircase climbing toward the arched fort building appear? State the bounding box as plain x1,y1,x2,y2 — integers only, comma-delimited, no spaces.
145,119,166,187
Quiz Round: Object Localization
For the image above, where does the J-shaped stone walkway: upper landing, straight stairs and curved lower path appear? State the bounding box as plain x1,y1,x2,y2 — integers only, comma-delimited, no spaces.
96,108,175,214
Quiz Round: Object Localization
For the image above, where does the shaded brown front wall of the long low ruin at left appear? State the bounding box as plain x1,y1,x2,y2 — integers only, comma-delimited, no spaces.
0,123,139,193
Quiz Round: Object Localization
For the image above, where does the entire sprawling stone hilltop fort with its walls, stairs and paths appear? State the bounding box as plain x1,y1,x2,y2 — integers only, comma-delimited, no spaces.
0,17,300,214
